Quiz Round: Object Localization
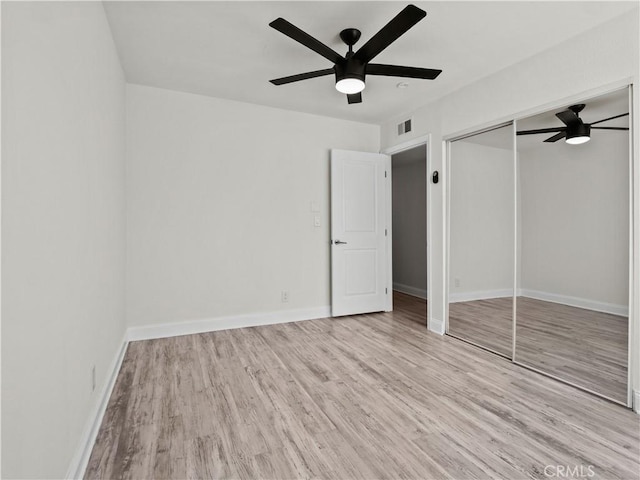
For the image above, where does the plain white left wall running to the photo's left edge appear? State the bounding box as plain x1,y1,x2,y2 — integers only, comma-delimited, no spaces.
2,2,125,478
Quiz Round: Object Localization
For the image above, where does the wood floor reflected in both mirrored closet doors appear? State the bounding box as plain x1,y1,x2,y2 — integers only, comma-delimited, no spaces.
449,297,628,403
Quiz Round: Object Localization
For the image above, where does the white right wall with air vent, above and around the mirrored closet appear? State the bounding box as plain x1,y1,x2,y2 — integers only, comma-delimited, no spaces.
381,11,640,388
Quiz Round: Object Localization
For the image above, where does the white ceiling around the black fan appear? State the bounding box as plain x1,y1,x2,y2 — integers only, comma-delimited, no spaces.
104,1,637,124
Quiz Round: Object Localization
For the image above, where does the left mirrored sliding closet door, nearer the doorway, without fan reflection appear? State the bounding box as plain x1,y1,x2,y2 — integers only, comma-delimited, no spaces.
447,124,515,358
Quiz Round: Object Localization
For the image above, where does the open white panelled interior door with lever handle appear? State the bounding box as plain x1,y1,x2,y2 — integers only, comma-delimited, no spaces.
331,150,391,317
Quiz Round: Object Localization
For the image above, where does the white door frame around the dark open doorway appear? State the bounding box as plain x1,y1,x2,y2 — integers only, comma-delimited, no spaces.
380,133,433,322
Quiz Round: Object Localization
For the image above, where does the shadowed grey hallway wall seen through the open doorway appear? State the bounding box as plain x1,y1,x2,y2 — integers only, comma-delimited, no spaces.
391,152,427,298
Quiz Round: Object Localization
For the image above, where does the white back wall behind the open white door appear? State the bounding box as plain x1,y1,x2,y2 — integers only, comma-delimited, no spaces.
126,85,380,326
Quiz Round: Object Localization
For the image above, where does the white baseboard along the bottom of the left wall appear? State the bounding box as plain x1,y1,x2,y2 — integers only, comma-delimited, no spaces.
65,336,128,479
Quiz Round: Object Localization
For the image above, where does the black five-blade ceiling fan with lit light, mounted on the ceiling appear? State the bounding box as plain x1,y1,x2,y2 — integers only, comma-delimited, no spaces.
269,5,442,103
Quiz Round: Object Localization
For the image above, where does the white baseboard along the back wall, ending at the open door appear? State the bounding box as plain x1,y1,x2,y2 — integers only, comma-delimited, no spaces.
127,306,331,342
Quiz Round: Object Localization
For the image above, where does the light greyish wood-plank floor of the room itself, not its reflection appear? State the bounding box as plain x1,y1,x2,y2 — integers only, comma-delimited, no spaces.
86,298,640,480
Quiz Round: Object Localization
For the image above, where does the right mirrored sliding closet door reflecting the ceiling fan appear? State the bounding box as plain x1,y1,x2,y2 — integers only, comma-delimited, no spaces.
514,89,630,404
